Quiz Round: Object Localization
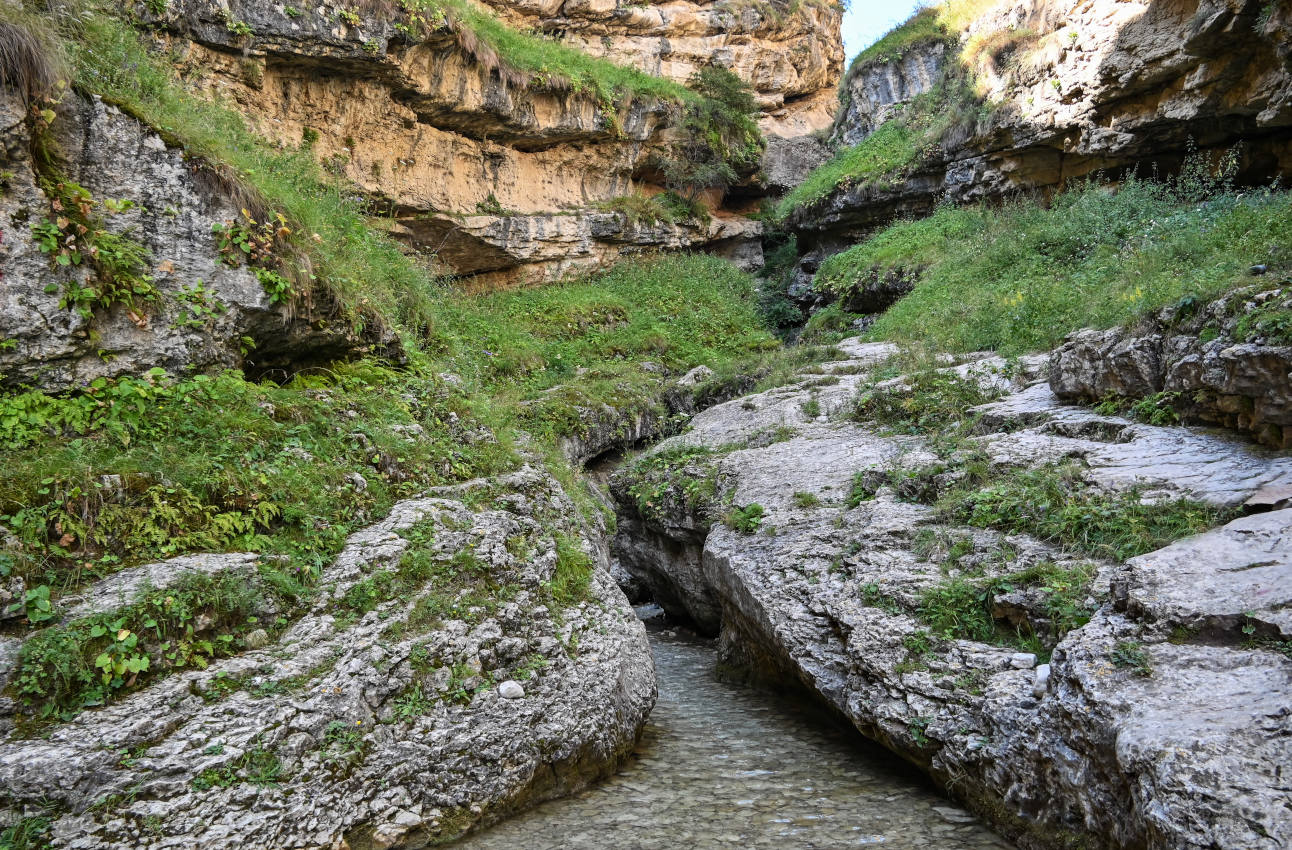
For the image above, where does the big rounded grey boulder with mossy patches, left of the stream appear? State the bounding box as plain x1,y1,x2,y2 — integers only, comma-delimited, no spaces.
0,468,655,849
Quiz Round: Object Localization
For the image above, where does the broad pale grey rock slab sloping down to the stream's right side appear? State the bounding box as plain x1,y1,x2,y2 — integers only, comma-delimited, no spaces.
615,344,1292,850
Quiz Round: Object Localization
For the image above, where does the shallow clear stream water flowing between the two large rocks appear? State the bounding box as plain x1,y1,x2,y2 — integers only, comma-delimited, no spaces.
455,622,1010,850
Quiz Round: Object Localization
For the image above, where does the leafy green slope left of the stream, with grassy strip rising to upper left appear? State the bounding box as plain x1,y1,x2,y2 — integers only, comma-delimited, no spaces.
0,6,775,714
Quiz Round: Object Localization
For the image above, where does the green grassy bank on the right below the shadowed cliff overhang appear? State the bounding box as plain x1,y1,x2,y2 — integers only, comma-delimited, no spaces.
818,180,1292,354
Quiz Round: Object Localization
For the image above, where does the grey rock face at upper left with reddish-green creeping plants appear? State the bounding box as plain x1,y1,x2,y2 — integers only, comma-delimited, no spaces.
0,90,398,389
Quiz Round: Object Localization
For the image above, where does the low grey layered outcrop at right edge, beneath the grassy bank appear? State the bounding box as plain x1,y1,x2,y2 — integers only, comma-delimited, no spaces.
1050,287,1292,448
